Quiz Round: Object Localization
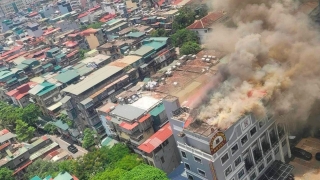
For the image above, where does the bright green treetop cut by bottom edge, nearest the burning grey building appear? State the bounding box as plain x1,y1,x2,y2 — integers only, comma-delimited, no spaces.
120,164,168,180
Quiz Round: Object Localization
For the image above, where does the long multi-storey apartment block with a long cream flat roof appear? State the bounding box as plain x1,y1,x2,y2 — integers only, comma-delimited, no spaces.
62,56,141,133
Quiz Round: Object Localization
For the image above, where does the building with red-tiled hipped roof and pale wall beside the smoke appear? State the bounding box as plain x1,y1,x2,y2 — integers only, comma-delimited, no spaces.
187,12,227,43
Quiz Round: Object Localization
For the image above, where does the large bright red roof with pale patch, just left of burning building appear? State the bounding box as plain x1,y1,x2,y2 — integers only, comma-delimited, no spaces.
138,123,172,153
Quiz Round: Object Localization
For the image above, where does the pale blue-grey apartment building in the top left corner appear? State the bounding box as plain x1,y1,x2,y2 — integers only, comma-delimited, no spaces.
0,0,26,16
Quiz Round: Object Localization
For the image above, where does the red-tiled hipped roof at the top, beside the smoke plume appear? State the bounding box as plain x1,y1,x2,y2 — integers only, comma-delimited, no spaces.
187,12,224,29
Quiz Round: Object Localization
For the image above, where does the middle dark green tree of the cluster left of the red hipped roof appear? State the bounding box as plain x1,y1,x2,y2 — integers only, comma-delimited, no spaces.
171,29,198,47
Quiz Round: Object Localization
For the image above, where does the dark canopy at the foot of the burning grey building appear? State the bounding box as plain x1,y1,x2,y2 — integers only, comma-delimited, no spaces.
259,160,294,180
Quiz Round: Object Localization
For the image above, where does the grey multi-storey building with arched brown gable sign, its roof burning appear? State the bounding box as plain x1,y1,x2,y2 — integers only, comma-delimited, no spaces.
170,108,292,180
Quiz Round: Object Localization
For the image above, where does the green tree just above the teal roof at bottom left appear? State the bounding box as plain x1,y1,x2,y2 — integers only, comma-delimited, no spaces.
25,159,60,179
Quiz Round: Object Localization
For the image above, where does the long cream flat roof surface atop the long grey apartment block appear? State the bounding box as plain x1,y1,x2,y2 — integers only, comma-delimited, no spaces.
62,65,123,95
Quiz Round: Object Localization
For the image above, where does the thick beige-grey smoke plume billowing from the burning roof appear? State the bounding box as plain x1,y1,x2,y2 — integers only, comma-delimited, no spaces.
199,0,320,128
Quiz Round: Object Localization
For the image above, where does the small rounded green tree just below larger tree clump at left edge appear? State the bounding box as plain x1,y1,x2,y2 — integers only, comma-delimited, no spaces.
16,120,36,141
